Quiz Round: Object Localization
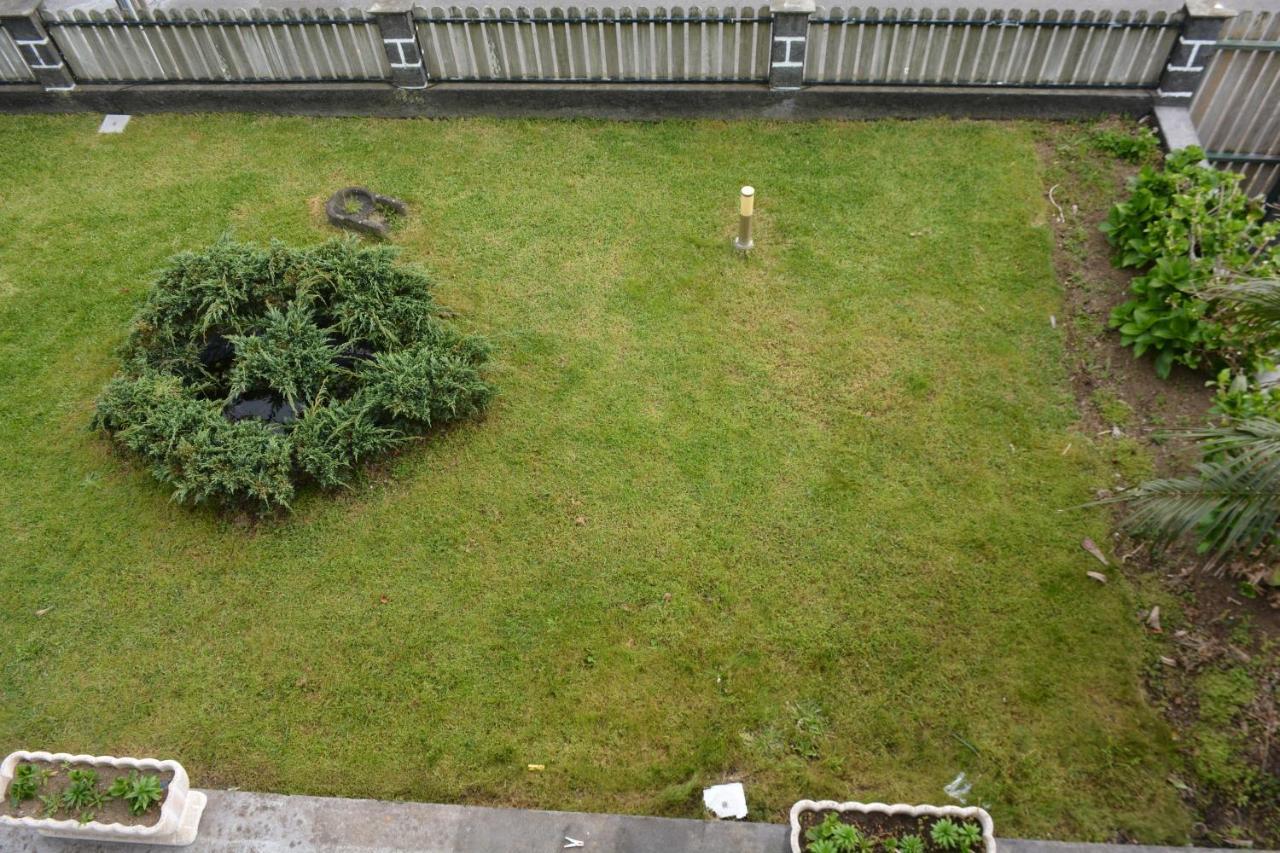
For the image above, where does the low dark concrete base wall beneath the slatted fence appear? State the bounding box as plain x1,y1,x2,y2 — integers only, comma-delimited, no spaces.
0,83,1152,119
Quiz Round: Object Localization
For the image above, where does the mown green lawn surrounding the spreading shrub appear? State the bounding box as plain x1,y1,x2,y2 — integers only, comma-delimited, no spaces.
0,117,1189,841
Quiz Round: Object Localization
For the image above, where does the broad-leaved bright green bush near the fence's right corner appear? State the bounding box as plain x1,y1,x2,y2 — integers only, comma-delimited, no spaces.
1102,147,1280,377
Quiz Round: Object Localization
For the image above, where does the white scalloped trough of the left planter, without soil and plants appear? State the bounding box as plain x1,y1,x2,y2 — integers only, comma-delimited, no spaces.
0,751,205,847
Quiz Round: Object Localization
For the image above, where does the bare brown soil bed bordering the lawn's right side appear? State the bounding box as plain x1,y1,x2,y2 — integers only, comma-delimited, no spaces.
1041,122,1280,848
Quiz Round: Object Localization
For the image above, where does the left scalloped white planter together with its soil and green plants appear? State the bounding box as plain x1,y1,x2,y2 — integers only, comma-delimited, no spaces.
0,752,205,844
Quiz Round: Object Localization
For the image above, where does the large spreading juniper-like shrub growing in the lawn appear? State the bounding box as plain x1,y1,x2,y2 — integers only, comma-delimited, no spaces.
93,240,493,514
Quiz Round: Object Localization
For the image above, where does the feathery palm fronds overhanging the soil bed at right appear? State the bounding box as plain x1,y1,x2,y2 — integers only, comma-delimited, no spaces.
1103,418,1280,563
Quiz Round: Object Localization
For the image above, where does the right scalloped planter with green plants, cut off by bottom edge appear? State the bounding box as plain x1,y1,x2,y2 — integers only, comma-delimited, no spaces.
791,799,996,853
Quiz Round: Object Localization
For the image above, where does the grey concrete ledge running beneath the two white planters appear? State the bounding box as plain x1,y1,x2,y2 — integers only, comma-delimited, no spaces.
0,790,1264,853
